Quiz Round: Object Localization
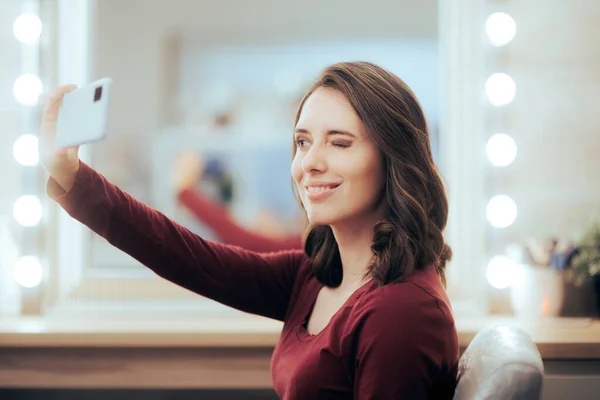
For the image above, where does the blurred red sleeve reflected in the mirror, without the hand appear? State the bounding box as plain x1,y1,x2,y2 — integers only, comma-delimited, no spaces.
178,188,302,252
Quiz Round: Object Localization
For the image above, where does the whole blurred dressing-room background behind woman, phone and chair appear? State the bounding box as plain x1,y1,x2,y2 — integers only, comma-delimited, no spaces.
0,0,600,399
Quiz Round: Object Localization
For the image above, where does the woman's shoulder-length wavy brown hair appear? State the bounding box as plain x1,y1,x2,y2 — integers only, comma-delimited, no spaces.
293,62,452,287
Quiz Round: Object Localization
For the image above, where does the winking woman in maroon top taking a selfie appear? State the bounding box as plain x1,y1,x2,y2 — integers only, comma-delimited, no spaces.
41,62,459,400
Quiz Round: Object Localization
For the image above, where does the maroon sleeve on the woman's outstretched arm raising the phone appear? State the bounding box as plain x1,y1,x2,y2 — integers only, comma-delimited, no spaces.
47,162,307,320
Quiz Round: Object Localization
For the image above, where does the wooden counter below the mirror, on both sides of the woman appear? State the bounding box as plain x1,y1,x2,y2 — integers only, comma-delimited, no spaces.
0,316,600,388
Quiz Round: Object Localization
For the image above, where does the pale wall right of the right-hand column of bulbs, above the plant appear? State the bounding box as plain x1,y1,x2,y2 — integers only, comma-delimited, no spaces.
489,0,600,247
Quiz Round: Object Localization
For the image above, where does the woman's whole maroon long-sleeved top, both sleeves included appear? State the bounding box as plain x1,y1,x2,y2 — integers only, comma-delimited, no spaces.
48,163,459,400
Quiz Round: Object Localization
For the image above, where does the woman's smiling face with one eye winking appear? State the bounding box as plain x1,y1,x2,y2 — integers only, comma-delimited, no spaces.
292,88,385,226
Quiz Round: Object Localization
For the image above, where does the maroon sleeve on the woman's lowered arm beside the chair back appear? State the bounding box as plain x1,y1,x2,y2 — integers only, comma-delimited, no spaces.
354,283,458,400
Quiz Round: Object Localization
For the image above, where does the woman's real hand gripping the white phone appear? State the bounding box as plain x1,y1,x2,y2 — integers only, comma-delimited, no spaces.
39,85,79,192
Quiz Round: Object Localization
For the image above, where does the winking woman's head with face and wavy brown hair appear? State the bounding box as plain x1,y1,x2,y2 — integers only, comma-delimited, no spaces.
292,62,451,294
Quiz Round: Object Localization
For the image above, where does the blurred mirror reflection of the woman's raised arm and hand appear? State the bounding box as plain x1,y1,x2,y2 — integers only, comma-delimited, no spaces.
174,152,302,252
